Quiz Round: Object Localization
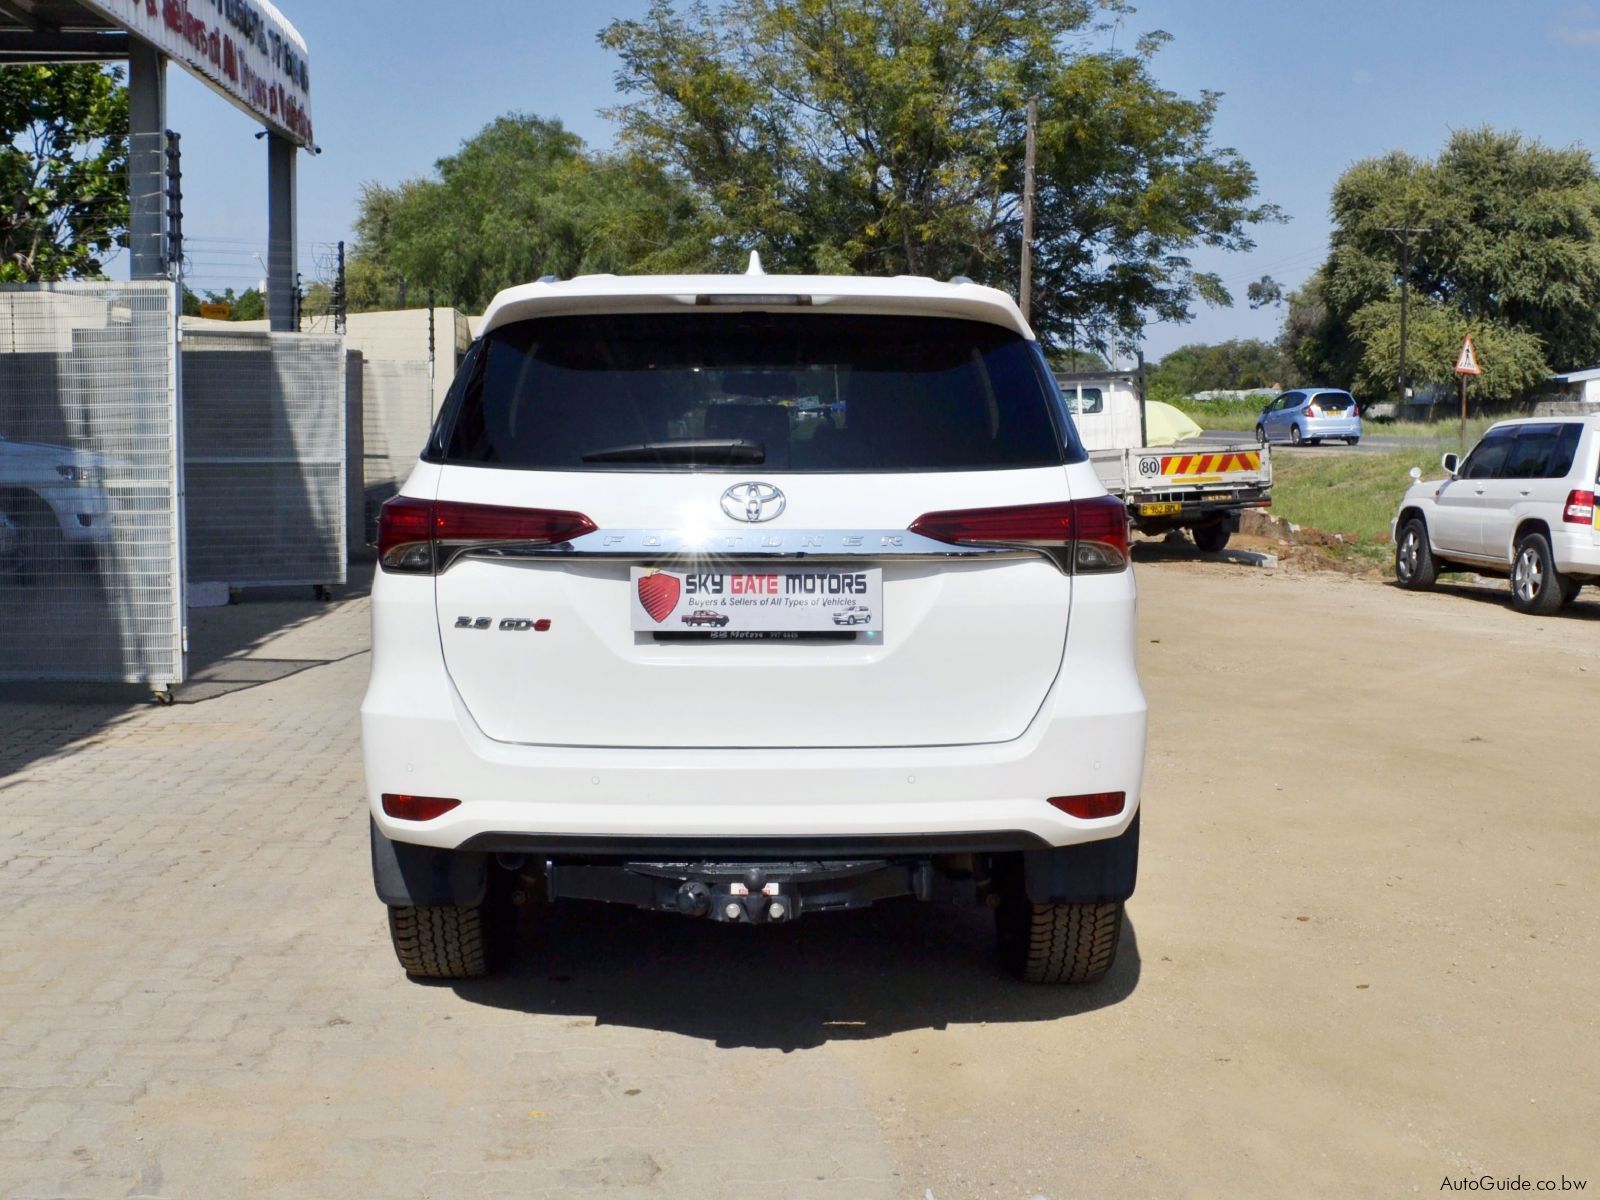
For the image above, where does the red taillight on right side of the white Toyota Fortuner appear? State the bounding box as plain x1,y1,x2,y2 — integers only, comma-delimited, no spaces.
910,496,1128,574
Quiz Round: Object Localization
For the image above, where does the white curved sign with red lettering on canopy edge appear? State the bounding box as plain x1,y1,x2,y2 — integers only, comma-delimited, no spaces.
78,0,315,146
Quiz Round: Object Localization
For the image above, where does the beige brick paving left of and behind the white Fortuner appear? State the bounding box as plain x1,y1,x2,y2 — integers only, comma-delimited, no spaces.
0,579,898,1197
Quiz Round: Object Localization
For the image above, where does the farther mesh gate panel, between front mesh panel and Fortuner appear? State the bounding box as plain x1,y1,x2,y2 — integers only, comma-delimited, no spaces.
182,331,346,587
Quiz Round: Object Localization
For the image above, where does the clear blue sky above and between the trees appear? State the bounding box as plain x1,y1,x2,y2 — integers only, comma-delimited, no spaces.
156,0,1600,358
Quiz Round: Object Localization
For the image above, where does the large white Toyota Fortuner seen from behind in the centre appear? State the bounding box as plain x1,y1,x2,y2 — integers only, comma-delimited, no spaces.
362,274,1146,982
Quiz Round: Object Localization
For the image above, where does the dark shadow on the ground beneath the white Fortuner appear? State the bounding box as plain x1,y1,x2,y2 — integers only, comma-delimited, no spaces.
448,901,1139,1051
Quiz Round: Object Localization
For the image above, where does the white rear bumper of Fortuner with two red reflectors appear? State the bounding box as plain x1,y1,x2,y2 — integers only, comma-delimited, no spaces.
362,573,1146,858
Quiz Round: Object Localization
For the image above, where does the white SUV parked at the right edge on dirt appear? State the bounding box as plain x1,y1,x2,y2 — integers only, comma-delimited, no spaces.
1394,416,1600,613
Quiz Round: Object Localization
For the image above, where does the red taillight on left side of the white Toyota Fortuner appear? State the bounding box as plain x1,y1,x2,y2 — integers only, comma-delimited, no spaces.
378,496,595,574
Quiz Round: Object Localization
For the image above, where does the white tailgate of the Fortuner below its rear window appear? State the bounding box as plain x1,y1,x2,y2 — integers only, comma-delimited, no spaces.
435,467,1072,747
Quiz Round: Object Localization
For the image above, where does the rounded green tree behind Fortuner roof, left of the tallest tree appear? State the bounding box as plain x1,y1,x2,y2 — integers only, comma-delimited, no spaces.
358,114,726,310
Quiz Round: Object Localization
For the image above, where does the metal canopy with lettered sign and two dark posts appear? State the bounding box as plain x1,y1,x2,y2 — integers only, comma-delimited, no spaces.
0,0,315,331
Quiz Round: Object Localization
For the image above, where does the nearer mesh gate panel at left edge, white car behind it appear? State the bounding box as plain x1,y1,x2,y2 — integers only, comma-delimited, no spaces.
0,282,184,686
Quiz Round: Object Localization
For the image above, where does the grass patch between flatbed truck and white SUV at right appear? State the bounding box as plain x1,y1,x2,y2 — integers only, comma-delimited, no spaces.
1272,443,1443,557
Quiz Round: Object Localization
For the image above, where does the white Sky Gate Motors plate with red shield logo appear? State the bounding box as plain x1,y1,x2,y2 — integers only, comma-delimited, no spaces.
629,566,883,635
